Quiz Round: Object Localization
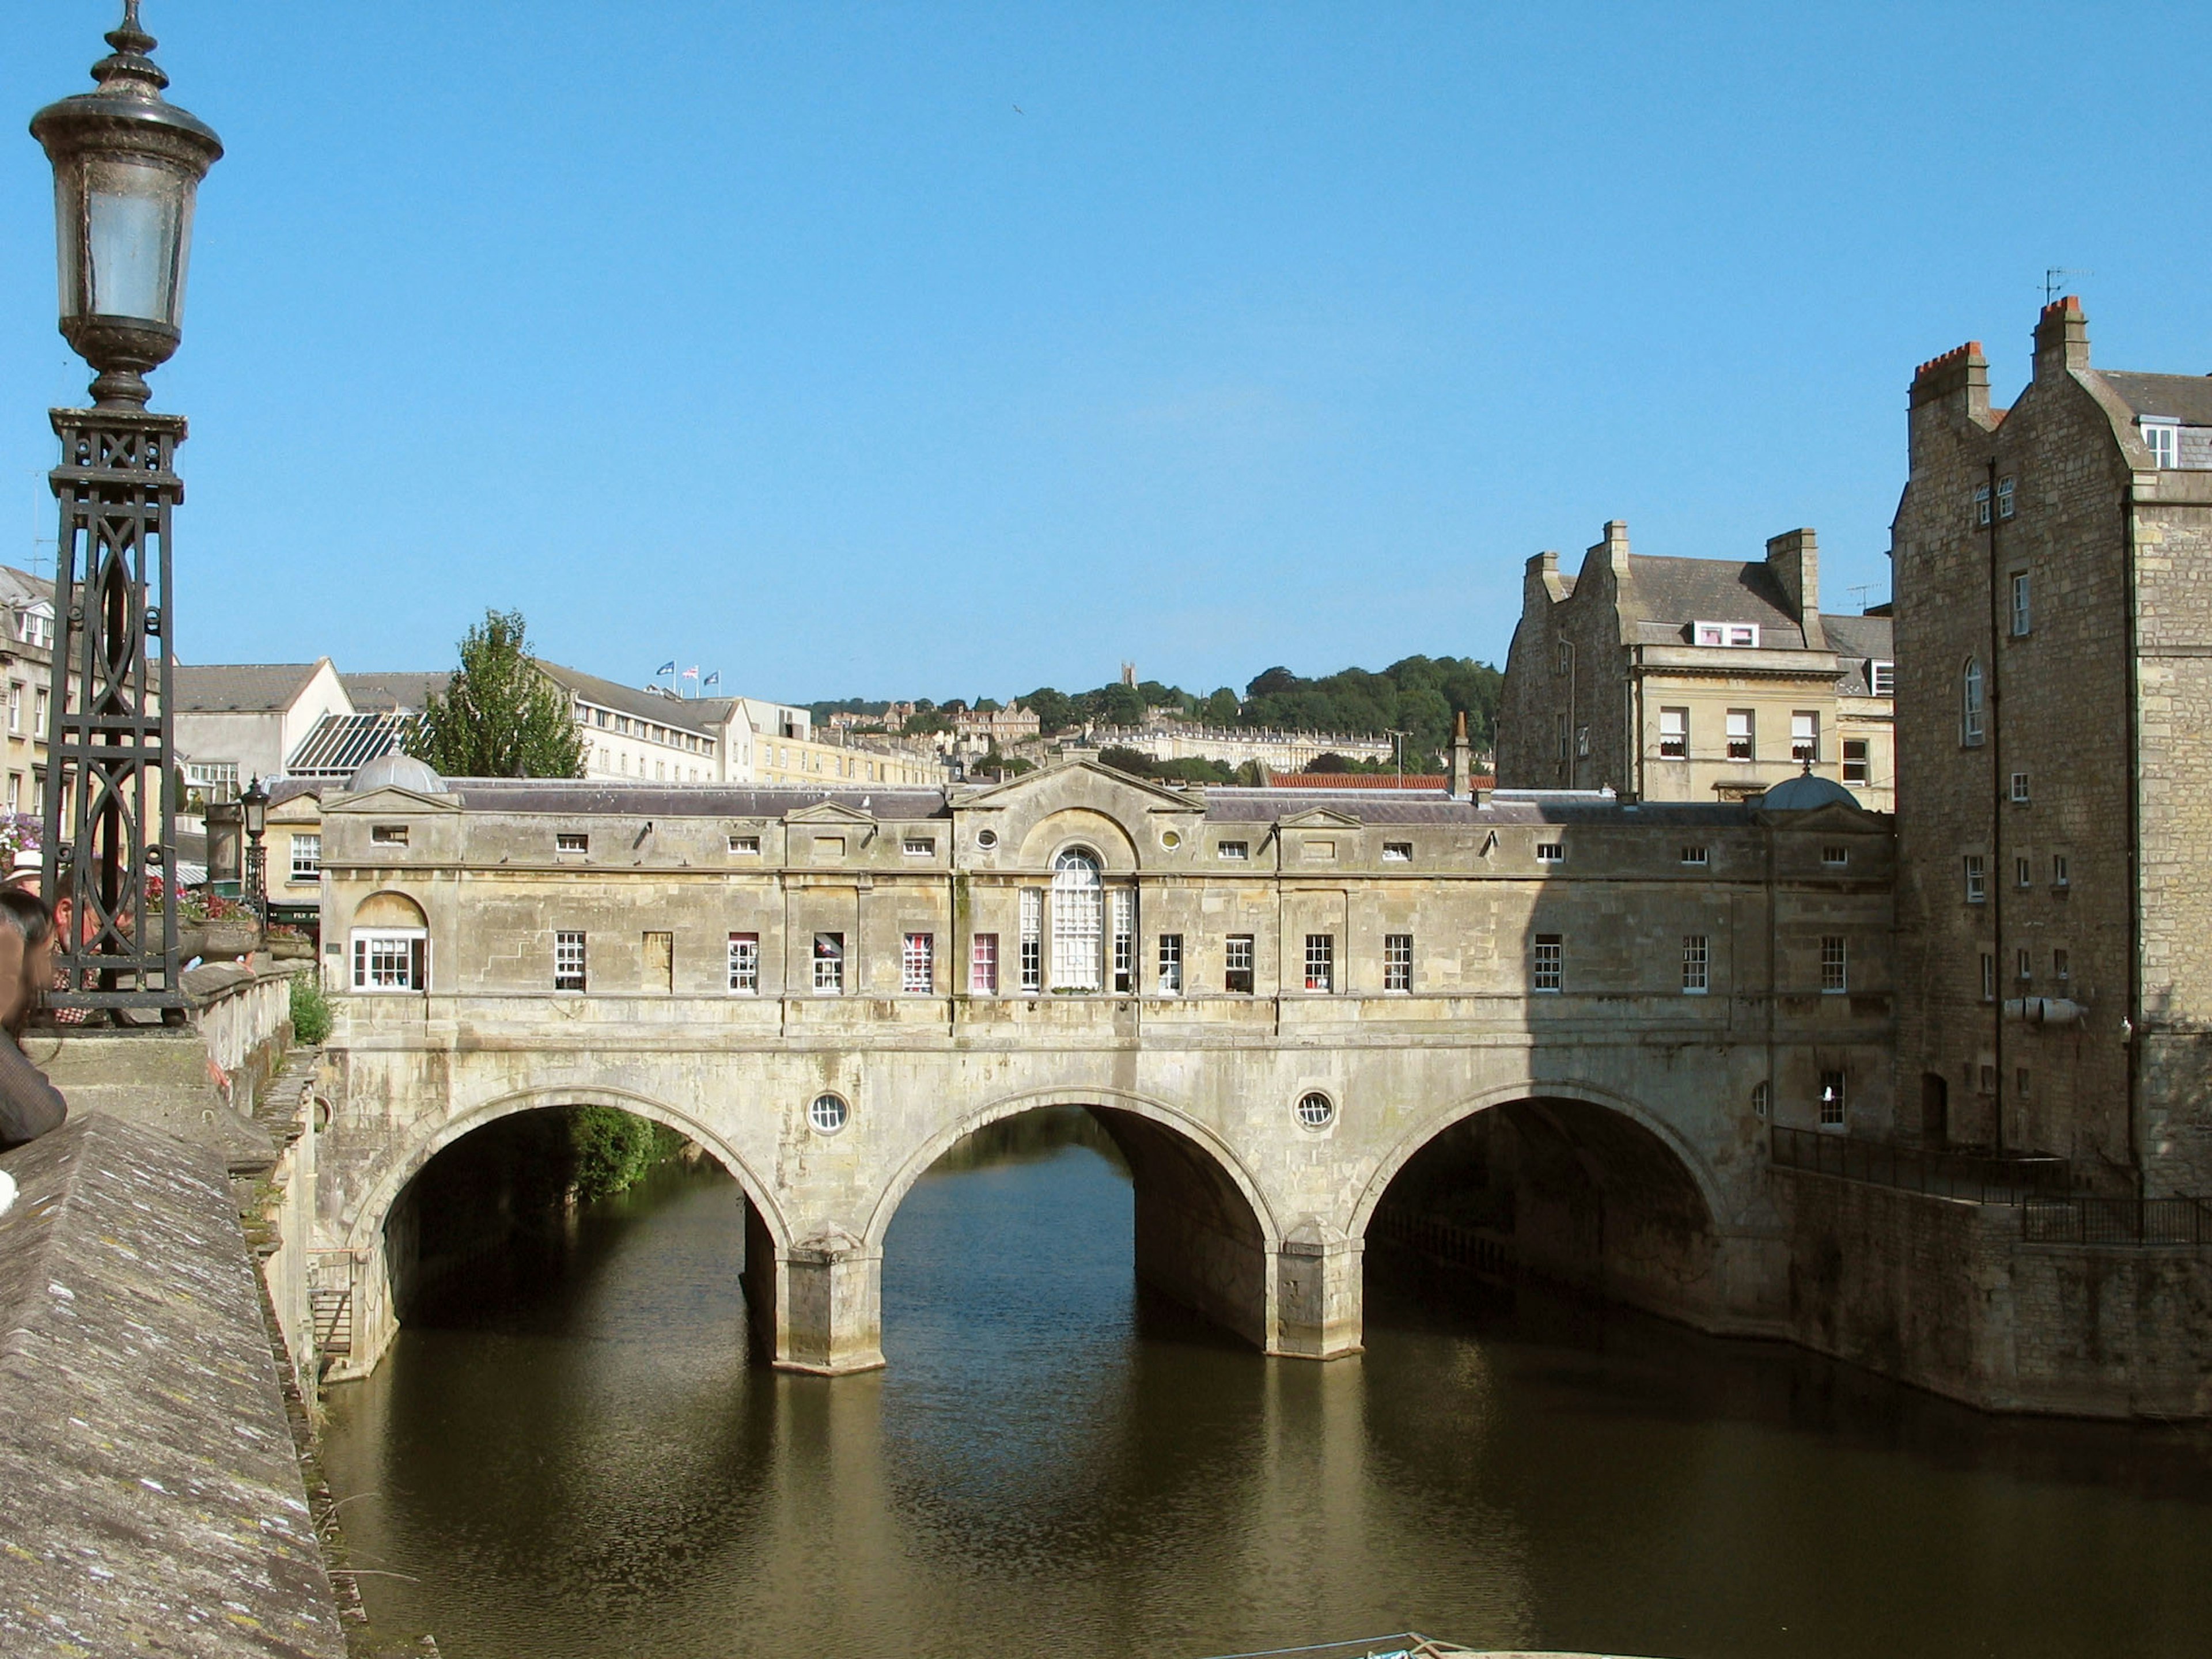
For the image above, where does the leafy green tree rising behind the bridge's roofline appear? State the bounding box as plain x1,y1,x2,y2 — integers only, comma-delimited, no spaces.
407,611,584,779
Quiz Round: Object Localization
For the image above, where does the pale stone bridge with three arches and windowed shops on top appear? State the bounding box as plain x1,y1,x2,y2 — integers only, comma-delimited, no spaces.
319,761,1891,1376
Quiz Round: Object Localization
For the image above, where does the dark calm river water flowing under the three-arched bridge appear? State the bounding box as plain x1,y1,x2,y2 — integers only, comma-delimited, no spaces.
325,1113,2212,1659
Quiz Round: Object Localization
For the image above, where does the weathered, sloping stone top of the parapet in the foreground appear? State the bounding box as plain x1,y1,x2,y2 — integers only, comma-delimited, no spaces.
0,1113,345,1659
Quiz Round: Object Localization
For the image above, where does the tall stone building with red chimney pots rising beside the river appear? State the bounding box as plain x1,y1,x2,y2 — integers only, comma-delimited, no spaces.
1891,298,2212,1195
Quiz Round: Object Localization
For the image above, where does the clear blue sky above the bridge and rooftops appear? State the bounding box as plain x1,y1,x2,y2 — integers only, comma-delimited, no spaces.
0,0,2212,701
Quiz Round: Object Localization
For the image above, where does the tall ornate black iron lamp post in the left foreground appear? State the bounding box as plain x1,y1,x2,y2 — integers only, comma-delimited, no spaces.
31,0,224,1017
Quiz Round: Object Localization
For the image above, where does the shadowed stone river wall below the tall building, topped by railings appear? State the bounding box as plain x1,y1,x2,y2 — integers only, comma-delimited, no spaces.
1774,1170,2212,1418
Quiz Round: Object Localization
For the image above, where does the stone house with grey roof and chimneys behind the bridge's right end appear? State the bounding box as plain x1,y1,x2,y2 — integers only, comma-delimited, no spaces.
1498,522,1896,812
